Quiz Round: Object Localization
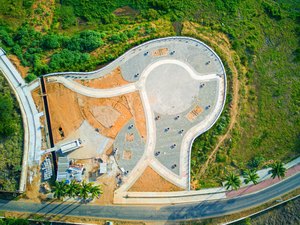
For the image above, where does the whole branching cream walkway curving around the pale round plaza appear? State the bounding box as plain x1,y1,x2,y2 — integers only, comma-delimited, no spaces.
47,54,226,195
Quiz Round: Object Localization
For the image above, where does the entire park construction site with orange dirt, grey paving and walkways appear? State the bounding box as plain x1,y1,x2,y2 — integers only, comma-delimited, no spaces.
31,37,226,204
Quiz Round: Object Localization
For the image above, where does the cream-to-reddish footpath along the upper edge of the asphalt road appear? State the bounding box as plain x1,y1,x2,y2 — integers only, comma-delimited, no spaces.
114,157,300,205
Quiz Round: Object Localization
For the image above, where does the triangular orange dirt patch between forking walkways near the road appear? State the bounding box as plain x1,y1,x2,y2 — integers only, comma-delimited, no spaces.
128,167,184,192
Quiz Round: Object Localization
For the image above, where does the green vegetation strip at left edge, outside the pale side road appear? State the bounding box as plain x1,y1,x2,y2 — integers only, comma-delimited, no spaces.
0,72,23,191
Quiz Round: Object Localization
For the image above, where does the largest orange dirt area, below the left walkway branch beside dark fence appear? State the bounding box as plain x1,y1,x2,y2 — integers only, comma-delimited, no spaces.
47,83,146,143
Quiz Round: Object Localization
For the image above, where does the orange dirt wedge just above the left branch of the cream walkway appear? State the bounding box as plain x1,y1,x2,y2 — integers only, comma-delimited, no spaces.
75,67,129,89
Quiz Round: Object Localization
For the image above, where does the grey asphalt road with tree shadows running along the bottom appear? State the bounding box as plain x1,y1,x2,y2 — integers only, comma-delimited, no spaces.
0,173,300,221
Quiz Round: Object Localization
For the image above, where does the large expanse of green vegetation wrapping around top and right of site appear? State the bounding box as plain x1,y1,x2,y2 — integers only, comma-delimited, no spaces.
0,0,300,188
